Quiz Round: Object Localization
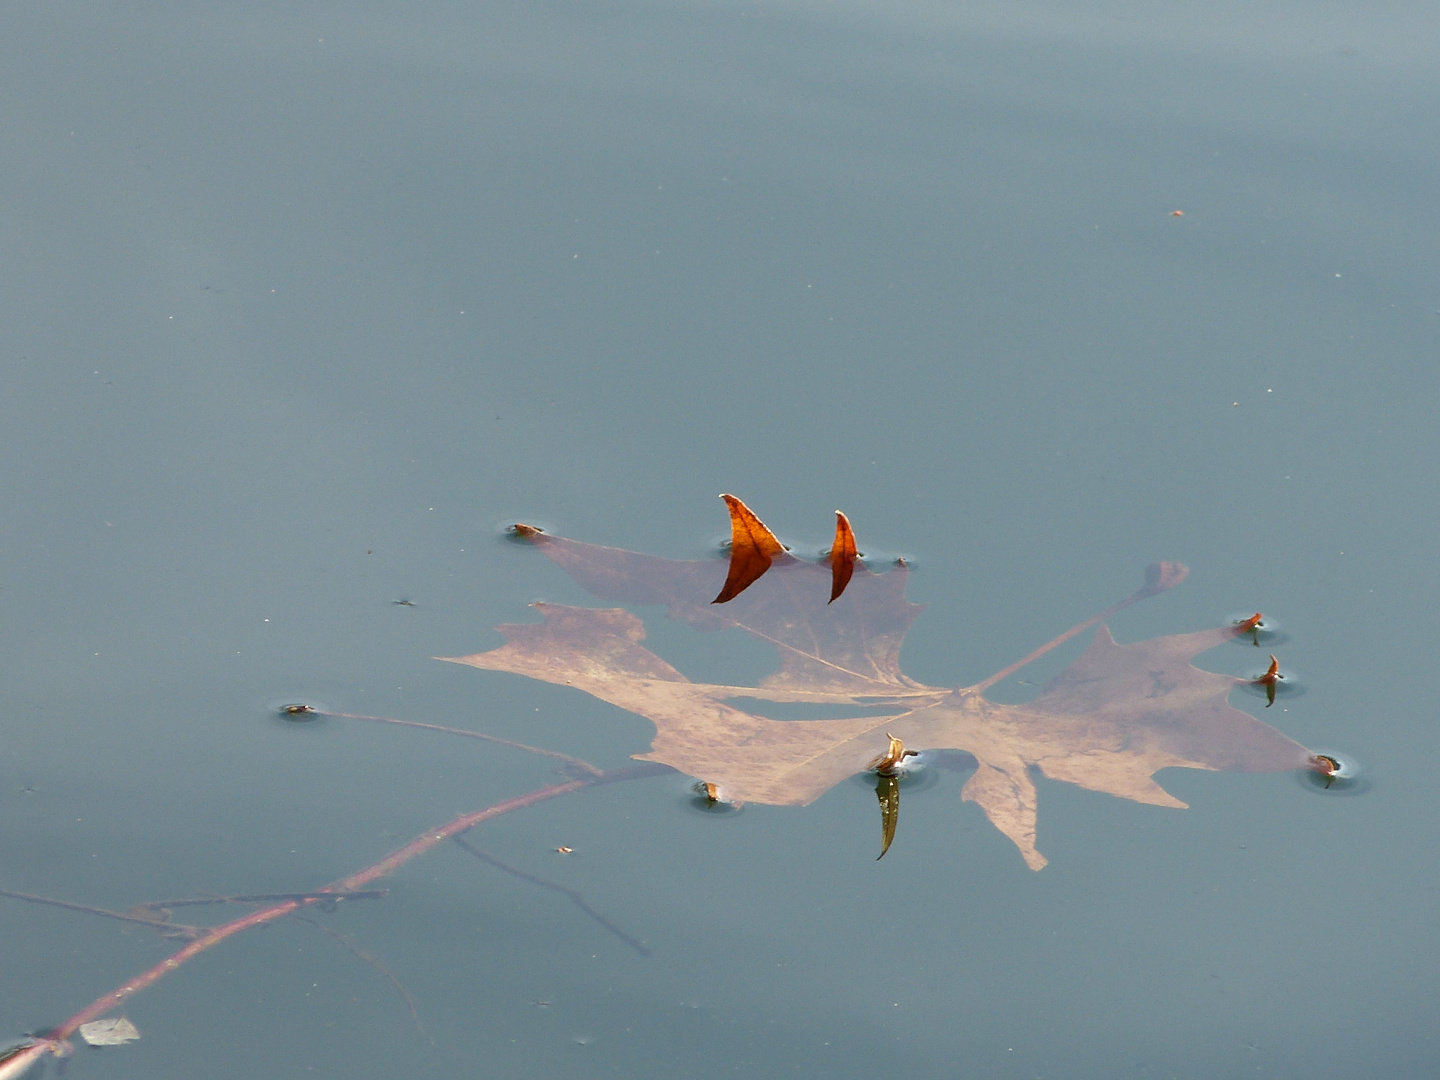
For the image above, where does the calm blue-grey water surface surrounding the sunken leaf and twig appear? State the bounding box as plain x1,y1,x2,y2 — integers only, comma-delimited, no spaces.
0,0,1440,1080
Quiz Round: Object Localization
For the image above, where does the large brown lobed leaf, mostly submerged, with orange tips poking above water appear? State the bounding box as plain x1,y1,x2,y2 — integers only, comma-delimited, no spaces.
448,495,1329,870
